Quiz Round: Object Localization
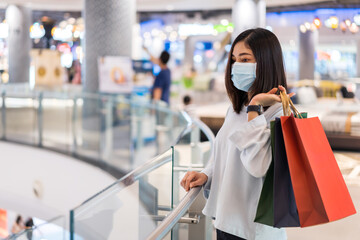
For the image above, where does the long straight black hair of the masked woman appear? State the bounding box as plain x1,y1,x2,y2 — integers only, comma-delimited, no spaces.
225,28,287,113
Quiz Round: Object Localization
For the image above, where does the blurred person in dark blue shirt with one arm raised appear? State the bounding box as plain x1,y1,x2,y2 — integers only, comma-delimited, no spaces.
144,47,171,105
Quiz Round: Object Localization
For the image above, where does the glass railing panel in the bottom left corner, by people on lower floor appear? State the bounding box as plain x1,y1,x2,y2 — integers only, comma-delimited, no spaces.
7,216,69,240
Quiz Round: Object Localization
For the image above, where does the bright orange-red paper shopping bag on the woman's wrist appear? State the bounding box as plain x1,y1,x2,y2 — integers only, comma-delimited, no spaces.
281,93,356,227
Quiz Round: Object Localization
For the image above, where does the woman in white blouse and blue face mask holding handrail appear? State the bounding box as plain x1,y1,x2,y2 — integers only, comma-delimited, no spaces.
181,28,293,240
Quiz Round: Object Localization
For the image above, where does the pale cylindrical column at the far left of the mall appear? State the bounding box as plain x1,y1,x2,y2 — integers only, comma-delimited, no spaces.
6,5,32,83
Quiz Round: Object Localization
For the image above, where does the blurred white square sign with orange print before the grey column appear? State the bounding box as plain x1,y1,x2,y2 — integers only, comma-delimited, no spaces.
98,56,133,93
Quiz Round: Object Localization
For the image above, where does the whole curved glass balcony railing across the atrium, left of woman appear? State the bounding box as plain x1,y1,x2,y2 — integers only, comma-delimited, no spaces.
2,88,187,172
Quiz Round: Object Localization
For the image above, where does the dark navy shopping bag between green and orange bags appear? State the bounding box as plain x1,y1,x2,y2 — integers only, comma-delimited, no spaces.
274,117,300,228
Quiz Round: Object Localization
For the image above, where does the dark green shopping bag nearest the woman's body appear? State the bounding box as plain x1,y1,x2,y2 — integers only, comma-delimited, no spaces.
254,121,275,226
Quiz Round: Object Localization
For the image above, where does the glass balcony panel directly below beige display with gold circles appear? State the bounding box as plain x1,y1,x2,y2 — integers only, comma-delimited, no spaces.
40,93,74,153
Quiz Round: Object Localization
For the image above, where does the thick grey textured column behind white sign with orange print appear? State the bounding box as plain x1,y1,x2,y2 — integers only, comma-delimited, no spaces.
83,0,136,92
